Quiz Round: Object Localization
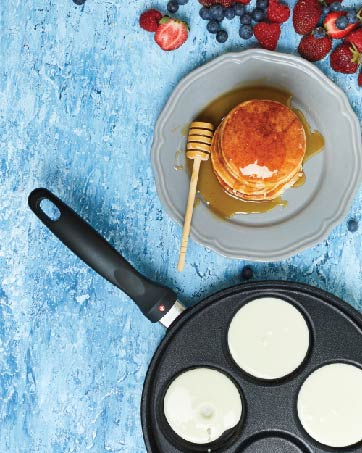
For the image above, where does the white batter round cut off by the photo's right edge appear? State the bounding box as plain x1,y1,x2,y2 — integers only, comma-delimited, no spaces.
298,363,362,448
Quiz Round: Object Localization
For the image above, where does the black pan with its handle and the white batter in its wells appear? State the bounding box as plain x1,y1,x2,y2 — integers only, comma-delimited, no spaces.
29,189,362,453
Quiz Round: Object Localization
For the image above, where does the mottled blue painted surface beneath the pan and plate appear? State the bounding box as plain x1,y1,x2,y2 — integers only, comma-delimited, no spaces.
0,0,362,453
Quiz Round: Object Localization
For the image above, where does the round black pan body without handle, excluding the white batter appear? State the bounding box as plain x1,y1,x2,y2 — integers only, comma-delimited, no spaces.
141,282,362,453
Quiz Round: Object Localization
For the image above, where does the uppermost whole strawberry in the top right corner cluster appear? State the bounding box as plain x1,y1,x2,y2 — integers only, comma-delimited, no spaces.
293,0,323,35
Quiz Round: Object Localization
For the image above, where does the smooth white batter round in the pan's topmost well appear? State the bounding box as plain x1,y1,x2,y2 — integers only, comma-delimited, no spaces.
228,297,310,380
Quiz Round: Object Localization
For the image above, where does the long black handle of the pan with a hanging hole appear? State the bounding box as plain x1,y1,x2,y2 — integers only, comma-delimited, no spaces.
28,189,177,322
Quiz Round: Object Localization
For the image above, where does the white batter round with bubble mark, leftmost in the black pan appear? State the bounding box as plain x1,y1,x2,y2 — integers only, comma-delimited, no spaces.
164,368,243,444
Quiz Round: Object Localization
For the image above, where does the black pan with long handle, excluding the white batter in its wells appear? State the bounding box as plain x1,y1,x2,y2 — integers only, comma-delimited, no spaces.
29,189,362,453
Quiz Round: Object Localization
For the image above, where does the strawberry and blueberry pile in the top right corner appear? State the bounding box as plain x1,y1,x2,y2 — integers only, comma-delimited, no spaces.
293,0,362,86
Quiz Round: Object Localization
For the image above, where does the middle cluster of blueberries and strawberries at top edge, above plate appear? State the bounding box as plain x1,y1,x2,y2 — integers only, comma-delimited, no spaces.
199,0,290,50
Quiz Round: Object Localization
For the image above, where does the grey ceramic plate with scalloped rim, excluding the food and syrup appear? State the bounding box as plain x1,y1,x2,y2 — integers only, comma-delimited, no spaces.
152,50,362,261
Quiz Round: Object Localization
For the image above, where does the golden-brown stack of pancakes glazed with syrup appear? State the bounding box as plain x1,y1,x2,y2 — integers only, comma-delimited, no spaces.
211,99,306,201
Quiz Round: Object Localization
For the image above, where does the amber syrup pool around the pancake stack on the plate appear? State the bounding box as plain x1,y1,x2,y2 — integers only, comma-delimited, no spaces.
184,86,324,219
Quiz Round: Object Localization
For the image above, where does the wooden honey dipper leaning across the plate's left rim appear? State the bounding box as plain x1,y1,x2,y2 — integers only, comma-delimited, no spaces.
177,121,215,272
